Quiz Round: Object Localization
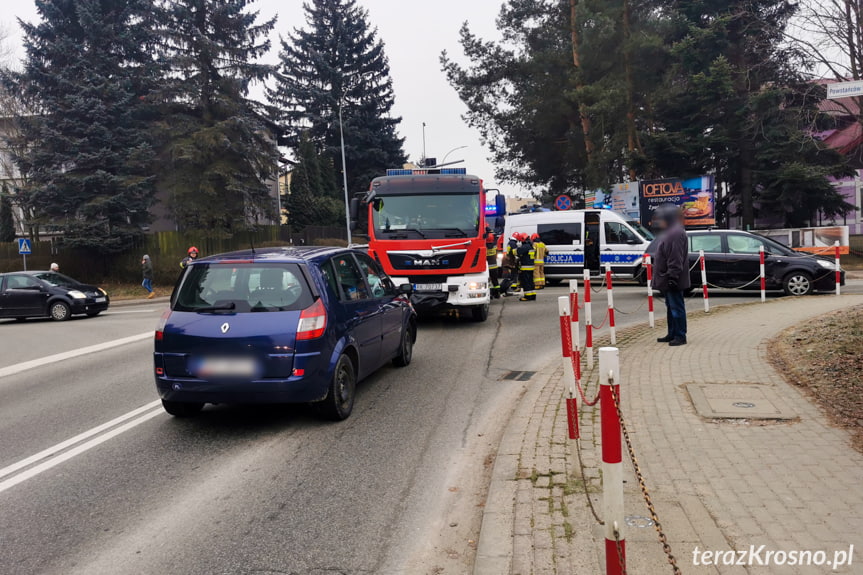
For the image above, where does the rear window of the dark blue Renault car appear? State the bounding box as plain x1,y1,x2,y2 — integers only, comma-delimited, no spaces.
173,262,314,313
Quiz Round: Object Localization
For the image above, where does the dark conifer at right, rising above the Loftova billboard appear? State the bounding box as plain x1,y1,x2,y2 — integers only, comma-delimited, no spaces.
645,0,852,227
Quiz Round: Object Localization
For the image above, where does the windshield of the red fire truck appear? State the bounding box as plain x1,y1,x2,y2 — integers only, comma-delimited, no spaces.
372,194,479,239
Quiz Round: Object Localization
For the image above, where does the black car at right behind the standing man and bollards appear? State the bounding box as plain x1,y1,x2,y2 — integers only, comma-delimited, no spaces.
647,230,845,295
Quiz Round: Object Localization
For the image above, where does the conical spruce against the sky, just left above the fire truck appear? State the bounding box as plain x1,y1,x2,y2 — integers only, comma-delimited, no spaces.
269,0,405,198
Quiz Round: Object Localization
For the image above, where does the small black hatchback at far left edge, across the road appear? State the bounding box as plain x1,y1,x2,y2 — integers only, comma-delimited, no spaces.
0,271,110,321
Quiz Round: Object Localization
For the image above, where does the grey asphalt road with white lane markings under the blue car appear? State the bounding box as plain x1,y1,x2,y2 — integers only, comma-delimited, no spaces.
0,281,863,575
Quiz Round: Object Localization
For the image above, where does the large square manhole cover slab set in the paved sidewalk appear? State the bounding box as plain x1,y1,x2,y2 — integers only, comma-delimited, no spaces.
686,383,797,419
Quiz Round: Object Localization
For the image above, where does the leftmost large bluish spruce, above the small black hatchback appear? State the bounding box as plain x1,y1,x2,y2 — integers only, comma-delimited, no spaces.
11,0,158,253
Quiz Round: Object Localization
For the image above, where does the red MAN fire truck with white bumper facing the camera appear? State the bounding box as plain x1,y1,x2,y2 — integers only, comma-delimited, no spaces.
351,168,506,321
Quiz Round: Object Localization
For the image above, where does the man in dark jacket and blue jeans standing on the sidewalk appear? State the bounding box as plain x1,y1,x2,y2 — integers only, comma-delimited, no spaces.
653,204,691,346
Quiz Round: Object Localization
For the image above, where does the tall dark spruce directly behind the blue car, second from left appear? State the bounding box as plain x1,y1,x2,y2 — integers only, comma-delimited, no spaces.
160,0,279,234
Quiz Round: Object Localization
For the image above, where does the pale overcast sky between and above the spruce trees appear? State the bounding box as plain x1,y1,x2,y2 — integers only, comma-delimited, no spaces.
0,0,524,195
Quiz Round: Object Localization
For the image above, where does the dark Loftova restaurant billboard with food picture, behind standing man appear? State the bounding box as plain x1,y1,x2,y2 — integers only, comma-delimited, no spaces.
639,176,716,227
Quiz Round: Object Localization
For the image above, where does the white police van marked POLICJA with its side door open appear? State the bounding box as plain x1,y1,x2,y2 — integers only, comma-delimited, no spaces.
504,210,653,283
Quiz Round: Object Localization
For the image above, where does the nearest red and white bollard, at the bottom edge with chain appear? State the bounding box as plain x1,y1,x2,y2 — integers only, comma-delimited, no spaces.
599,347,626,575
